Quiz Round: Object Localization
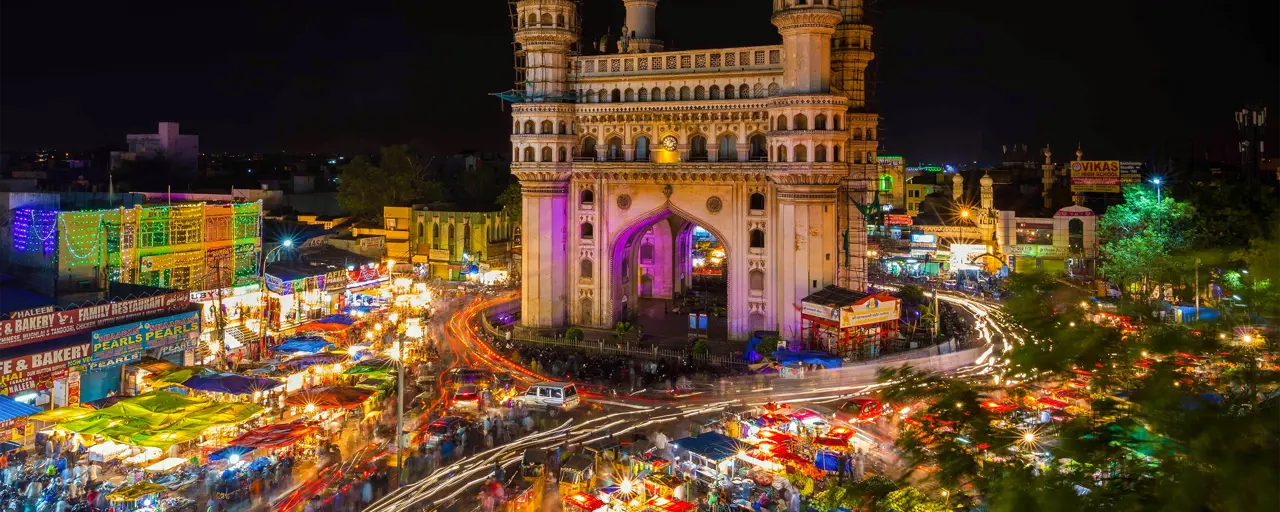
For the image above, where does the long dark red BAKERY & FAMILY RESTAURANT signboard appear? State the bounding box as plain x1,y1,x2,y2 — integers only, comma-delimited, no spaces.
0,292,191,348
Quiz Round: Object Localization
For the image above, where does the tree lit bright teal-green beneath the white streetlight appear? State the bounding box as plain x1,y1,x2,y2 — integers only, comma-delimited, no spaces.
1098,186,1201,296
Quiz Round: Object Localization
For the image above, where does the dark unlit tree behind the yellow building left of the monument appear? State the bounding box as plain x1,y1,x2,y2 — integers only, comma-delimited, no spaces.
338,145,445,219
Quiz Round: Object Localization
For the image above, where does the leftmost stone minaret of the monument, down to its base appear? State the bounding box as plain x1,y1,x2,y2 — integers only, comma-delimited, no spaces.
511,0,579,328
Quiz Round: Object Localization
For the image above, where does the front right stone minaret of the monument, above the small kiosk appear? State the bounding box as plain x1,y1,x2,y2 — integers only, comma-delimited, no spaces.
768,0,849,339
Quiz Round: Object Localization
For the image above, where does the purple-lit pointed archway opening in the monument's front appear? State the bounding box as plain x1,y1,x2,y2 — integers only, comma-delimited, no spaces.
608,209,737,343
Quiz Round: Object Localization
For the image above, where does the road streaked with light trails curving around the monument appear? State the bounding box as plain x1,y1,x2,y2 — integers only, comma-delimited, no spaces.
367,288,1021,512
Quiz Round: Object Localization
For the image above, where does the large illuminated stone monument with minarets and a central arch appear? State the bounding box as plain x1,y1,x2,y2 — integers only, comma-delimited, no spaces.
511,0,877,339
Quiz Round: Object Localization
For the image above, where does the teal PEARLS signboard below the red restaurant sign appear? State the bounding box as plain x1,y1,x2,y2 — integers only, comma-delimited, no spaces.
88,311,200,369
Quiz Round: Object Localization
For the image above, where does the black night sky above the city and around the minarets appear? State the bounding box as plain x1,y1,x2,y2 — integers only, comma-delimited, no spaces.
0,0,1280,163
